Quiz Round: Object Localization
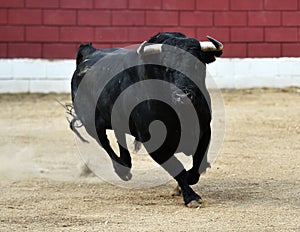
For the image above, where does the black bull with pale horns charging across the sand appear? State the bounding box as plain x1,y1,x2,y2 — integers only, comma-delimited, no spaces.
71,33,222,205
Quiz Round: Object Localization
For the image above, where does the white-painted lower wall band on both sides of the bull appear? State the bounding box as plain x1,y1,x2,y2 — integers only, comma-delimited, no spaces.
0,58,300,93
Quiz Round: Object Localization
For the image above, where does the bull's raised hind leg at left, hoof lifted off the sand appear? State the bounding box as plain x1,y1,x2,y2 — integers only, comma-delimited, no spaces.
97,130,132,181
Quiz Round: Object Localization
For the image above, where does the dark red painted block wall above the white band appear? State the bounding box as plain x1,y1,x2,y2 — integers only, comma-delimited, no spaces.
0,0,300,58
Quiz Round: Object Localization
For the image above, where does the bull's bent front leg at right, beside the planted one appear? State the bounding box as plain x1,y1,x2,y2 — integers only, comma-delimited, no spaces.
187,127,211,185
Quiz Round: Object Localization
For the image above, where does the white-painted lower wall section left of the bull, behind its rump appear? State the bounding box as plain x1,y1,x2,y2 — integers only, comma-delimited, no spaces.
0,59,76,93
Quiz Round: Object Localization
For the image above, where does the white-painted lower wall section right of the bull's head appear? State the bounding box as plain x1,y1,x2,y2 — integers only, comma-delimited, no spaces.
208,58,300,88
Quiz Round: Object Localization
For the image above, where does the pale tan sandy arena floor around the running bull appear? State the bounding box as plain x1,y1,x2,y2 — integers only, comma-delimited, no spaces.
0,88,300,232
